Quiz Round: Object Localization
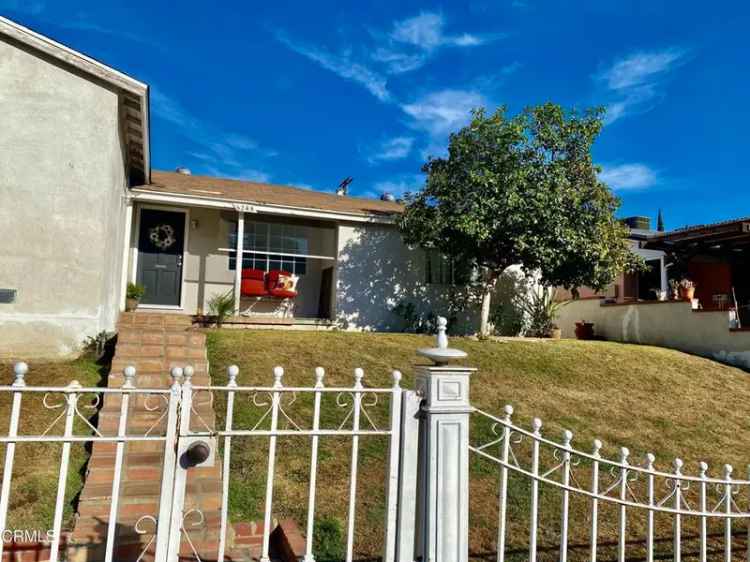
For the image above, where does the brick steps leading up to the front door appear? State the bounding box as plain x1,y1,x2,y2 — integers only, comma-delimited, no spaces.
71,312,228,562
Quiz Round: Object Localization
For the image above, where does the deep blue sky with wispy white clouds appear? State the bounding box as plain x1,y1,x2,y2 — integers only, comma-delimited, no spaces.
0,0,750,228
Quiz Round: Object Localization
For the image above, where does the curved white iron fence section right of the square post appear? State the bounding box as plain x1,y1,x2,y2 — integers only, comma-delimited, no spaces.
469,406,750,562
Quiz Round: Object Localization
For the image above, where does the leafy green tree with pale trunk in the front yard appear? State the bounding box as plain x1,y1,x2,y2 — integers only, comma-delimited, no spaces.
400,103,642,334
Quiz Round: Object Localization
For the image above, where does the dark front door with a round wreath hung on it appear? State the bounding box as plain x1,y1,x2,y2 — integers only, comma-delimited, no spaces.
137,209,185,306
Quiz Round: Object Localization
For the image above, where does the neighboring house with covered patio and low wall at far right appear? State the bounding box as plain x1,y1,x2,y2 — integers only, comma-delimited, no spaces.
558,214,750,368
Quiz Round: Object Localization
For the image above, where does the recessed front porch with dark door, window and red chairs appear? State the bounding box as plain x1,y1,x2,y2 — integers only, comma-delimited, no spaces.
126,201,337,328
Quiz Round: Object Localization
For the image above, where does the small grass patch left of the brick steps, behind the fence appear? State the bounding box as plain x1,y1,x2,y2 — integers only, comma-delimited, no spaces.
0,358,107,530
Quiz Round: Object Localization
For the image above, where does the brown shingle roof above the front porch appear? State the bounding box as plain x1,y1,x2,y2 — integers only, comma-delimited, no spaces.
134,170,403,215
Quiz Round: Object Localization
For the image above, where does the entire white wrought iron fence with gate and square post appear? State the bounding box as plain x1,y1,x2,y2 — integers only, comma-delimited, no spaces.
0,320,750,562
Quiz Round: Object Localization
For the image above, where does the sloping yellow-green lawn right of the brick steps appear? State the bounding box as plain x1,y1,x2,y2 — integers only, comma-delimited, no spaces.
209,331,750,560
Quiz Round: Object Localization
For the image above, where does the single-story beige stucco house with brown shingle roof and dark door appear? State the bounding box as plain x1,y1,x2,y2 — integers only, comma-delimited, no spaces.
0,17,470,357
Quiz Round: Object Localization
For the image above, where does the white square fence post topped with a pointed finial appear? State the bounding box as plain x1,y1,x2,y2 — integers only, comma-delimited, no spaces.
415,317,476,562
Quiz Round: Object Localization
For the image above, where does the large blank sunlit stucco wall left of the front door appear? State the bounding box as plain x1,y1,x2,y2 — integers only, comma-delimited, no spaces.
0,39,126,359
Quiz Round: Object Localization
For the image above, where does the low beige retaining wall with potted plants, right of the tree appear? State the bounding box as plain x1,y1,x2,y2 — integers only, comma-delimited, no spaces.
557,299,750,368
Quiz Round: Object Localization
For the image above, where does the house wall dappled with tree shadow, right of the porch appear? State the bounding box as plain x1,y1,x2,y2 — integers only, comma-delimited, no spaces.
336,224,477,331
